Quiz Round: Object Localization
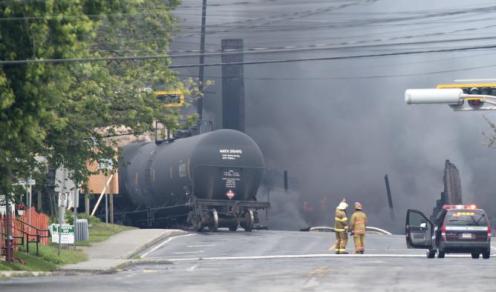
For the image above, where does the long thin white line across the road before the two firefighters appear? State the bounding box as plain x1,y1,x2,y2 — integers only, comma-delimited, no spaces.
160,253,434,262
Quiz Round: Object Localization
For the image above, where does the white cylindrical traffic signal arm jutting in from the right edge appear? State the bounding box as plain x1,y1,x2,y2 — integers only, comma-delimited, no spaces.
405,88,496,111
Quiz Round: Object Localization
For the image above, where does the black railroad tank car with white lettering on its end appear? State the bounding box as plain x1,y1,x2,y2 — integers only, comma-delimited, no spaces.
116,129,270,231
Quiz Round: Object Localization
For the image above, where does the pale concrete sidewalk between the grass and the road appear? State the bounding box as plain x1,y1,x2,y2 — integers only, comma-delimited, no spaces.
60,229,186,273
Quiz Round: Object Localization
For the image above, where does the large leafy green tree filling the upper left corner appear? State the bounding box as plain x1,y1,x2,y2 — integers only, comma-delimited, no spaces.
0,0,182,201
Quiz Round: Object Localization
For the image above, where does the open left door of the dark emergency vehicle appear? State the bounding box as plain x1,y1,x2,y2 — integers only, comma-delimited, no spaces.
405,209,434,249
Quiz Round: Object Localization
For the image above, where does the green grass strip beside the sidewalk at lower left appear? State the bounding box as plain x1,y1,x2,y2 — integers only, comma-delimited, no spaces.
0,217,133,271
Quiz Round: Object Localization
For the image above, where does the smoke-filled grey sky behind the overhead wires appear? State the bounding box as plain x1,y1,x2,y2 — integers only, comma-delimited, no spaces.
171,0,496,232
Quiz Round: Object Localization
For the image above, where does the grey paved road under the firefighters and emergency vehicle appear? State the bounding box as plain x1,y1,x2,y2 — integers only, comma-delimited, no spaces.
0,231,496,292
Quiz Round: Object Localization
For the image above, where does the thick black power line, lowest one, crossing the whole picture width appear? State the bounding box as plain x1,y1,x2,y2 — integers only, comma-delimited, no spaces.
0,44,496,69
